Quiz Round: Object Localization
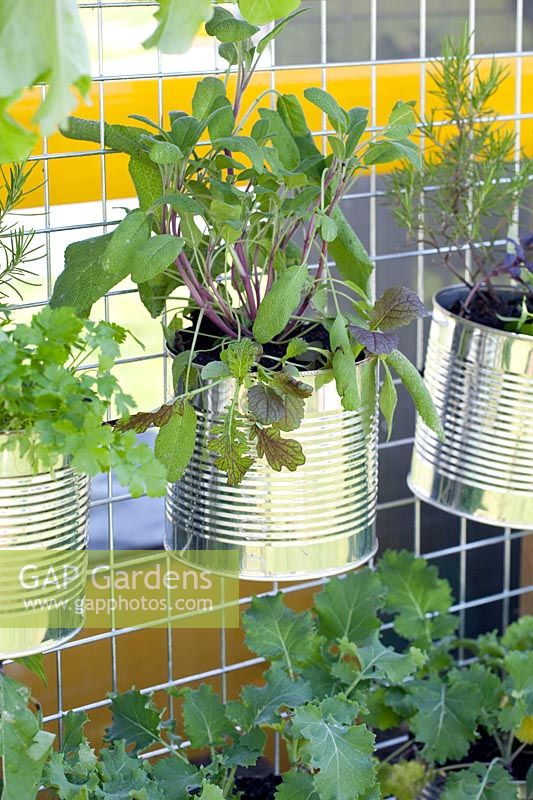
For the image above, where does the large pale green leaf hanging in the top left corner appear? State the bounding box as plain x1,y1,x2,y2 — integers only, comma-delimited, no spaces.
0,0,91,147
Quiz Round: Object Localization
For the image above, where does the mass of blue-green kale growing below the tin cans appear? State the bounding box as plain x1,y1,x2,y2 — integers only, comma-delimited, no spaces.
7,551,533,800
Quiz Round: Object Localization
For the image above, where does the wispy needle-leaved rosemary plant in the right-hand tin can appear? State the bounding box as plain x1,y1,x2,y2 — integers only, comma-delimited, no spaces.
389,30,533,320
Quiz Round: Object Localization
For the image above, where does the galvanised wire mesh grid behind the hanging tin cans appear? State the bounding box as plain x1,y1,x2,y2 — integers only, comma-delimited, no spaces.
4,0,533,752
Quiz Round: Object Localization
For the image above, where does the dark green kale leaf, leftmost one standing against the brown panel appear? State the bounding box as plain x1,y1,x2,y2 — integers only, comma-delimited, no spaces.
105,689,163,753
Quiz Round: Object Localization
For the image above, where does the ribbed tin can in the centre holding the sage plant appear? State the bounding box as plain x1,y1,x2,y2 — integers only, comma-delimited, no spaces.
165,360,378,580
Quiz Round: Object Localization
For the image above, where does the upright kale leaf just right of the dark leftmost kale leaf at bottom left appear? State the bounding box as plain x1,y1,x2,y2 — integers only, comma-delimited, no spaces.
183,683,232,748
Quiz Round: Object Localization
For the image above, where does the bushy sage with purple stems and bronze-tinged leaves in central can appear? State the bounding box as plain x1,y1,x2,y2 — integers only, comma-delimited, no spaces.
48,7,442,485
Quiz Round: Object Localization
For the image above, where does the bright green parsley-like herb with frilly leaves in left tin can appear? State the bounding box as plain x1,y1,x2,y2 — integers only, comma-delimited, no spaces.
0,307,165,496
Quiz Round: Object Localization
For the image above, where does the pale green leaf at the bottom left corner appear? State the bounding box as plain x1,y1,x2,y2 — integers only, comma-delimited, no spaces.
0,673,55,800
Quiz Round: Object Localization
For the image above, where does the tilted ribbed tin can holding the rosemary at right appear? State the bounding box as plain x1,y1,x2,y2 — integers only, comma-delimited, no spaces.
408,287,533,529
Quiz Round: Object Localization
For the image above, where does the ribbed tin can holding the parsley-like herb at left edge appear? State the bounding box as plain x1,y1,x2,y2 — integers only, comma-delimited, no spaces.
0,434,89,660
